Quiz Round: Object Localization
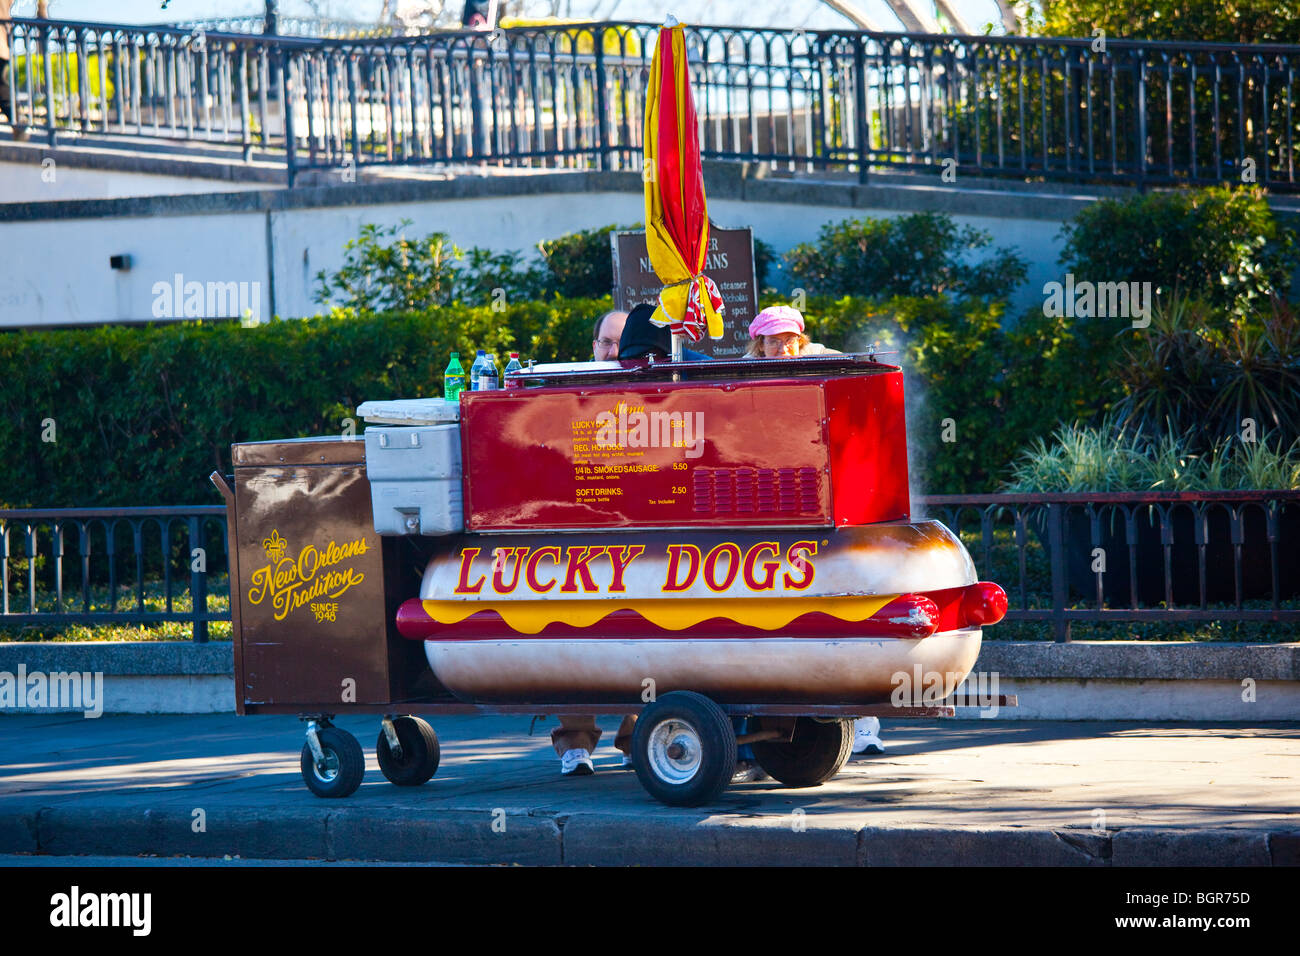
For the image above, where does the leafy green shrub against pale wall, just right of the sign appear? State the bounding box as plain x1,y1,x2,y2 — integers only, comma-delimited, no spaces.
785,212,1028,299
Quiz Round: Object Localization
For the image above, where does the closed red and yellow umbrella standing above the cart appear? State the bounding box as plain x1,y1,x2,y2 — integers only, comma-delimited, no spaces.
645,23,724,342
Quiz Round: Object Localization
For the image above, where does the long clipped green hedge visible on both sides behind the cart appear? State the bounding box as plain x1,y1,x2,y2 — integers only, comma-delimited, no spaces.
0,297,1119,507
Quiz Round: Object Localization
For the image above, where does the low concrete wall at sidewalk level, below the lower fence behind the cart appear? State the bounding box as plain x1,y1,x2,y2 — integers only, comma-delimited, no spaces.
0,641,1300,723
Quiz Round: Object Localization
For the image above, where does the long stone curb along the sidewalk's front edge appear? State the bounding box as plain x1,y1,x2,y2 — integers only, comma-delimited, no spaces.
0,805,1300,866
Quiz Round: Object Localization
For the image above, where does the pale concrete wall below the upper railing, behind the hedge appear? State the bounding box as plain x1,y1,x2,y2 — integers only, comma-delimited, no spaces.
0,165,1095,326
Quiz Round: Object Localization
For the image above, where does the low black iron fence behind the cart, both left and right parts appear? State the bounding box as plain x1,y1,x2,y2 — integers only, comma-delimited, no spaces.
0,492,1300,641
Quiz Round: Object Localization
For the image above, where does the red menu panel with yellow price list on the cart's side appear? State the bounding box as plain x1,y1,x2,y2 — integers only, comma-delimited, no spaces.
462,382,829,531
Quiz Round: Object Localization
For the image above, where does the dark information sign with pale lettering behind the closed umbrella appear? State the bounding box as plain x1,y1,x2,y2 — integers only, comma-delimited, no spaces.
610,224,758,358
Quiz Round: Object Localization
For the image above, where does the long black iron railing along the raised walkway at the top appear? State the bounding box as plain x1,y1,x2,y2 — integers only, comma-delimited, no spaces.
7,20,1300,190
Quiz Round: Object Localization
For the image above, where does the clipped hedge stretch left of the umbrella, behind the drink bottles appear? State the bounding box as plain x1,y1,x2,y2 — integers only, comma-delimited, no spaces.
0,298,610,507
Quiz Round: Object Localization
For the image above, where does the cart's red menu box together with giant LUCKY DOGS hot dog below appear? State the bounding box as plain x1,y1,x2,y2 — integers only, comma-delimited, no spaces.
377,359,1006,705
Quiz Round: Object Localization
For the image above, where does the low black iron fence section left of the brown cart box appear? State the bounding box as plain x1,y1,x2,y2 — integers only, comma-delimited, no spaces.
0,505,230,643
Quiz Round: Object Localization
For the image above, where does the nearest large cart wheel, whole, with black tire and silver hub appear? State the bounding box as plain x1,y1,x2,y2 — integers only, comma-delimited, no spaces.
632,691,736,806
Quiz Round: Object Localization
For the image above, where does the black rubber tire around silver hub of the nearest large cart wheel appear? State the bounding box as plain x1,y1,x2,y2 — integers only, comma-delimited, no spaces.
632,691,736,806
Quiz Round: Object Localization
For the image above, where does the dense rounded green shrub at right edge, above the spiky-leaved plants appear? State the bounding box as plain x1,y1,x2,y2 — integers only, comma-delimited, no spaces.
1060,186,1300,311
